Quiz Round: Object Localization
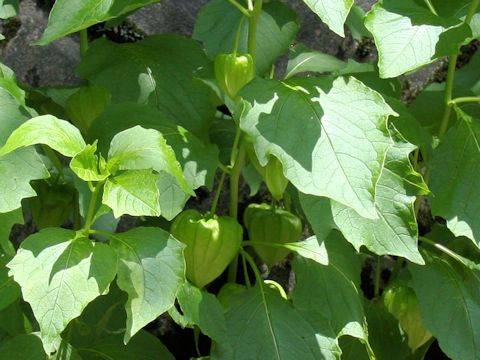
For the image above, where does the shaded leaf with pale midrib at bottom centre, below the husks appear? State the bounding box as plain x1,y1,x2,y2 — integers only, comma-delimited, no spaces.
212,284,340,360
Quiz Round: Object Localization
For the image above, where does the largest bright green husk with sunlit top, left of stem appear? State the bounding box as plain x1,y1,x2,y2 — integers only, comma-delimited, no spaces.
171,209,243,288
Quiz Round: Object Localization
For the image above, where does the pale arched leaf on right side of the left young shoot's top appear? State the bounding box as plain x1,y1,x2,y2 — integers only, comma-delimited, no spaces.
108,126,194,195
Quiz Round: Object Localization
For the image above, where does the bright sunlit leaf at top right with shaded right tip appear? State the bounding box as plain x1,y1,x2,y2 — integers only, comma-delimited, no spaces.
365,0,471,78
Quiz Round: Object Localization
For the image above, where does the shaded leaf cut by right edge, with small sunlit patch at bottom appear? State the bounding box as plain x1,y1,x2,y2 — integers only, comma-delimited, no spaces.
430,109,480,247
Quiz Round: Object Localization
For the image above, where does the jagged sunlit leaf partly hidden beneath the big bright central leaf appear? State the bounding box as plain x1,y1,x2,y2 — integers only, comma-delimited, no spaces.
300,134,428,264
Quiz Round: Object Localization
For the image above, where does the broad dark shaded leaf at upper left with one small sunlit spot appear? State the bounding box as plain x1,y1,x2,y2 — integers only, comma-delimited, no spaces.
77,35,215,136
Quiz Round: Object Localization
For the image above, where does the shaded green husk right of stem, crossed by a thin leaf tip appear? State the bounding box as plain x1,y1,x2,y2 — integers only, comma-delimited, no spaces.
244,204,303,267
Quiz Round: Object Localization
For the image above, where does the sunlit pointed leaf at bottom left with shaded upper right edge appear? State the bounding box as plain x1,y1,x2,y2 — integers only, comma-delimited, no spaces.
7,228,117,353
